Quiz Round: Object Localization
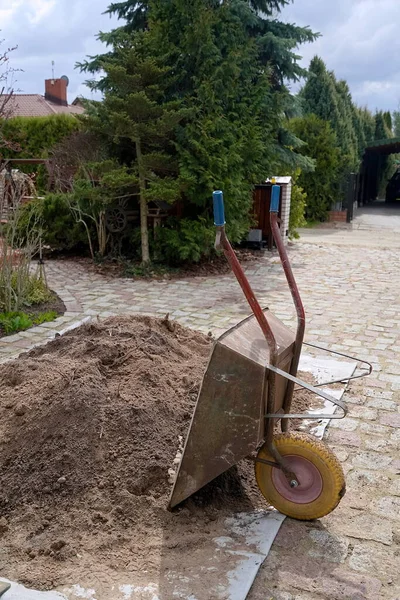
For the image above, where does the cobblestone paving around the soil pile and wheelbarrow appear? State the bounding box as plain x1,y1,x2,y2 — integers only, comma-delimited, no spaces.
0,204,400,600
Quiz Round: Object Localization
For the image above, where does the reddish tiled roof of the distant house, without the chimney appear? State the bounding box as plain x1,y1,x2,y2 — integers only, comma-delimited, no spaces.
3,94,85,117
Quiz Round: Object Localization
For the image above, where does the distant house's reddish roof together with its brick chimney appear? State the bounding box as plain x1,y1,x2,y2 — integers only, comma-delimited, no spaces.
3,76,85,119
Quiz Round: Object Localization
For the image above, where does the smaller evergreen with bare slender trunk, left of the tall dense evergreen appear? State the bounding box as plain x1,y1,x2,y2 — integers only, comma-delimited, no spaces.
85,31,185,263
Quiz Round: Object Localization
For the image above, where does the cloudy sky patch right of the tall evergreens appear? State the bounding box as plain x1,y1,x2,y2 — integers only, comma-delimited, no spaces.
283,0,400,110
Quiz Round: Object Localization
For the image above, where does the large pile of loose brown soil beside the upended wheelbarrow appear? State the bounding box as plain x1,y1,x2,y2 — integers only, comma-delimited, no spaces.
0,317,316,589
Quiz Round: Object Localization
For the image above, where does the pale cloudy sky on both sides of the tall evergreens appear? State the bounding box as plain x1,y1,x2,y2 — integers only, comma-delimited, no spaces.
0,0,400,110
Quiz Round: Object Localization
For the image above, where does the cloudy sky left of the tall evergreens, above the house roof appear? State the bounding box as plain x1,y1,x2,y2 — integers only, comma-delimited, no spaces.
0,0,117,102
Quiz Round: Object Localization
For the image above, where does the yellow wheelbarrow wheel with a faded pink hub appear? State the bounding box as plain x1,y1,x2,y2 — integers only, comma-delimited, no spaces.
255,432,346,521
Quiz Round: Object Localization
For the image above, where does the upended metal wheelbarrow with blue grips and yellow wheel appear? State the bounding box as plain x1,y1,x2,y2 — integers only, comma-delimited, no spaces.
169,185,372,520
